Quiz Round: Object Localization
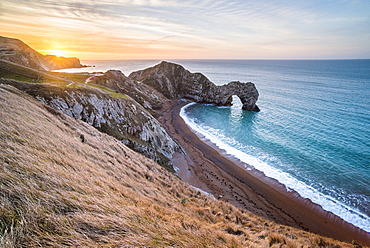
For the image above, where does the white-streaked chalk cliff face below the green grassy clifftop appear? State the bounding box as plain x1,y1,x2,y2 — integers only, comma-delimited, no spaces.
0,79,182,171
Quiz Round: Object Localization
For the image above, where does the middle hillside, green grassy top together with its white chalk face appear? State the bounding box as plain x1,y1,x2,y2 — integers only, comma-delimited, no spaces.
0,60,181,169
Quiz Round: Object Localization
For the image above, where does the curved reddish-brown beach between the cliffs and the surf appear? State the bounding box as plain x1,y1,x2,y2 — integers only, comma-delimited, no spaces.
159,101,370,246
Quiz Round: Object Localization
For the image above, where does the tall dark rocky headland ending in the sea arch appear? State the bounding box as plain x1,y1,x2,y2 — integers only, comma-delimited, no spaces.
129,62,259,111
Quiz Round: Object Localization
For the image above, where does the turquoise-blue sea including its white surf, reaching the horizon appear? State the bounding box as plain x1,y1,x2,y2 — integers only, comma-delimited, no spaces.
56,59,370,232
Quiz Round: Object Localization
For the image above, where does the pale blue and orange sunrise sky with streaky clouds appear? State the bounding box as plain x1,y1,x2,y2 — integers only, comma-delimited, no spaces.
0,0,370,60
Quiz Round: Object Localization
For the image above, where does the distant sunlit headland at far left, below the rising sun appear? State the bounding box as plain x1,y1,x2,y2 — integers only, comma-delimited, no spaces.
0,36,82,71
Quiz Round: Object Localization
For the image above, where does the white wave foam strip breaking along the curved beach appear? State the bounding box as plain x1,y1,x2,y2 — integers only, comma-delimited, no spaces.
180,103,370,232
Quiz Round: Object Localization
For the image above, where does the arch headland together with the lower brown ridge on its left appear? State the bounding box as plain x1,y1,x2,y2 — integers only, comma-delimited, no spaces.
91,61,259,113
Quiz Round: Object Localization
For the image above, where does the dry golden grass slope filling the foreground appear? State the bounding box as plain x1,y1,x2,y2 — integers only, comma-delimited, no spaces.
0,85,362,247
